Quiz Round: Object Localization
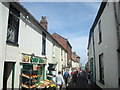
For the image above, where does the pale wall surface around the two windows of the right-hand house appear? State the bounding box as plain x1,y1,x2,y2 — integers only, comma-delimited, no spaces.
94,3,118,88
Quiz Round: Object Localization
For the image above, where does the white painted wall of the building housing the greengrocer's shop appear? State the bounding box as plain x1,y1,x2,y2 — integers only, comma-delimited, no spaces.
0,3,52,89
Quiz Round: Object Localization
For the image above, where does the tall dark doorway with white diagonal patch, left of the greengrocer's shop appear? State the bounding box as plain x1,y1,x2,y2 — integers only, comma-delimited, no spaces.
3,62,15,90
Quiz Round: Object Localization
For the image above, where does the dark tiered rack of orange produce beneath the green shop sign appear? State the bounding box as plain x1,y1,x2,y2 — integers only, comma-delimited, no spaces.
20,63,43,89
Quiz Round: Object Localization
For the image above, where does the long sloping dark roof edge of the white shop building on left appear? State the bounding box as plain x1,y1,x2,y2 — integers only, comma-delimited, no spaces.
11,2,66,51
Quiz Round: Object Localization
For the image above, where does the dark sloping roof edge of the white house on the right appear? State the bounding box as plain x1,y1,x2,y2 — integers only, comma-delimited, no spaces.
87,0,108,49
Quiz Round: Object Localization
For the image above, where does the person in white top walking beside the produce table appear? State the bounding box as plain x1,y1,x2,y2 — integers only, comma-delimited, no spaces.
56,71,65,90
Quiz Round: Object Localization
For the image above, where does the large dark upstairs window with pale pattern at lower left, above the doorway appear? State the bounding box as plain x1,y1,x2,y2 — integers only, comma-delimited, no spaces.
6,5,20,44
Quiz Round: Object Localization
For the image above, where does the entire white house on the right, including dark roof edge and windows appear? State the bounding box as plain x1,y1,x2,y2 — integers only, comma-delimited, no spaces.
88,2,120,88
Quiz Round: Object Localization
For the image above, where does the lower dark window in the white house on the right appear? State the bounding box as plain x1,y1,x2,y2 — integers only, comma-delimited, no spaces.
99,54,104,84
